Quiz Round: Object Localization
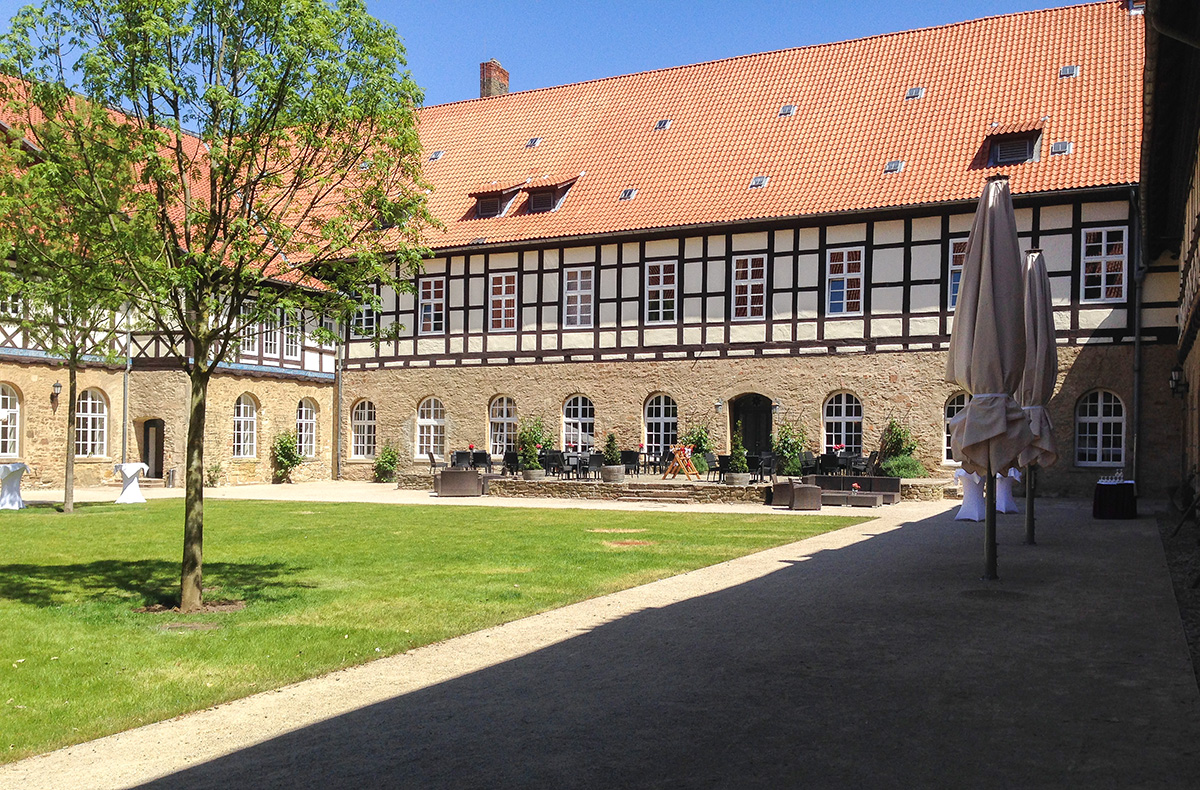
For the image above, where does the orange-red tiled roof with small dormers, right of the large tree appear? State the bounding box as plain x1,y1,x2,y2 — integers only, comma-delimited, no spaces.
420,0,1144,249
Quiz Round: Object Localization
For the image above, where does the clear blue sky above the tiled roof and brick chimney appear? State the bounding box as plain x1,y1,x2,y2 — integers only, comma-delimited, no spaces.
0,0,1073,104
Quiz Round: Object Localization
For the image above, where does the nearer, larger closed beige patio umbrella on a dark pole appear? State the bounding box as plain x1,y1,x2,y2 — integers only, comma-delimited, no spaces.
946,175,1033,579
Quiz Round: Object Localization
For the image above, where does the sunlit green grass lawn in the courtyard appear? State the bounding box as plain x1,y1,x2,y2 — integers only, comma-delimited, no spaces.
0,501,865,761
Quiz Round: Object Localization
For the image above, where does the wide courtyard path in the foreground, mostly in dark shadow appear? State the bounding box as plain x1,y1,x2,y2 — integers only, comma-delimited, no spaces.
0,497,1200,790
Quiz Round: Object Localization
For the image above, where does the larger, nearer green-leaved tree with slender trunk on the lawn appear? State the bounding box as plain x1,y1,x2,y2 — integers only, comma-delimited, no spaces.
0,0,432,611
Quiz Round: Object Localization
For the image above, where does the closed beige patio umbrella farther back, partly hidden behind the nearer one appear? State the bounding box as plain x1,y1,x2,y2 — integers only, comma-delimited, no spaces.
1016,250,1058,545
